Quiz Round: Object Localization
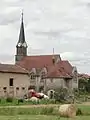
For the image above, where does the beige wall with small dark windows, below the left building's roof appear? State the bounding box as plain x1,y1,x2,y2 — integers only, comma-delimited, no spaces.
0,73,30,97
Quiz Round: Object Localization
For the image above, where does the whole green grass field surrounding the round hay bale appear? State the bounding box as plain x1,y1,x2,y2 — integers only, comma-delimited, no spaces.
0,104,90,120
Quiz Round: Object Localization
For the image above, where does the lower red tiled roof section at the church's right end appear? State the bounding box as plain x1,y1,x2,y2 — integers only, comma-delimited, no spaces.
47,61,73,78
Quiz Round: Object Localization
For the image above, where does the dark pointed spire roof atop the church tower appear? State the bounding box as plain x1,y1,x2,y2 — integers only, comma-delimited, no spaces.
18,12,25,43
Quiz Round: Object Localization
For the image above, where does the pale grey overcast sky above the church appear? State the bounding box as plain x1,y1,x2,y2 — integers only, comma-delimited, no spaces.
0,0,90,73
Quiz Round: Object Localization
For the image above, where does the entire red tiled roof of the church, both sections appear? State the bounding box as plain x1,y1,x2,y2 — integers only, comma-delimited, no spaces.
17,54,73,78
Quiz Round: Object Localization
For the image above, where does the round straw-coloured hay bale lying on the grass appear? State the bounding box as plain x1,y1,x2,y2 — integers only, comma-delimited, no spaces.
59,104,76,117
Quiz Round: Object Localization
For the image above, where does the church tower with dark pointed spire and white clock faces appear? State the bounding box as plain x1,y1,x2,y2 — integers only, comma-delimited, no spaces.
15,12,27,62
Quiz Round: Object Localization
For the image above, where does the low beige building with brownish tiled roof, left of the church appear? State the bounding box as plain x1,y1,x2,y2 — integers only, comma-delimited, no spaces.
0,64,30,97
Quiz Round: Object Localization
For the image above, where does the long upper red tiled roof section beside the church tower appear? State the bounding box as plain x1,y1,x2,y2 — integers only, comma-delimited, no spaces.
17,54,61,70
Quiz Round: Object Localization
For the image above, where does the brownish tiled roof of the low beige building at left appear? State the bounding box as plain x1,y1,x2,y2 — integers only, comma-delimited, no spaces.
0,64,28,74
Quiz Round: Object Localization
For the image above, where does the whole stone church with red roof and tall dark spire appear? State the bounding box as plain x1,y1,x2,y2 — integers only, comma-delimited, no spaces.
16,12,78,91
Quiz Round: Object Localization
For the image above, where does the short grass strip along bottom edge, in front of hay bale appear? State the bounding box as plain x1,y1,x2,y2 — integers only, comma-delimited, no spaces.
0,115,90,120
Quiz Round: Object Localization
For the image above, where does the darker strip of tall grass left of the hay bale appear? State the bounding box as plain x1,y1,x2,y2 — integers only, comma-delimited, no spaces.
0,107,56,115
